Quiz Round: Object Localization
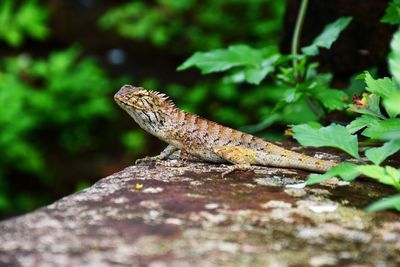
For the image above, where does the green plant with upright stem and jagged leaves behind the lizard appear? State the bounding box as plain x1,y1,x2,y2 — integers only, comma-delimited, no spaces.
178,15,351,131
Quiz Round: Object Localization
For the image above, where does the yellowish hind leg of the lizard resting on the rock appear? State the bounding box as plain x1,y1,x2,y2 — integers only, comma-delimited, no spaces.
213,146,257,177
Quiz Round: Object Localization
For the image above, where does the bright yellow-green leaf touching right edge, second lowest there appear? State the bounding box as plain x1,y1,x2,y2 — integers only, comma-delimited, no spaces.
357,165,400,191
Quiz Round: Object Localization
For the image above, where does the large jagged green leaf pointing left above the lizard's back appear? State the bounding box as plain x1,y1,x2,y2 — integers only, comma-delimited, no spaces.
178,45,263,74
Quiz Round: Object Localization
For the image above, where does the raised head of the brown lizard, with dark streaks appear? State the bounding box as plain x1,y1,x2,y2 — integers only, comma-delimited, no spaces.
114,85,175,134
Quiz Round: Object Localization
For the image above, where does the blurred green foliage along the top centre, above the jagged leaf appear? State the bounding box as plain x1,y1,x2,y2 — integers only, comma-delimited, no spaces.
99,0,284,52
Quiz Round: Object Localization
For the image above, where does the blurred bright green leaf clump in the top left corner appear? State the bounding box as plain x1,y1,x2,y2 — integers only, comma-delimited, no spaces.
0,0,49,47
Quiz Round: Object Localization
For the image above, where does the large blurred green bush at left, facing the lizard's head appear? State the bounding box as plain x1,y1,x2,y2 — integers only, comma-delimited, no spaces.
0,47,114,216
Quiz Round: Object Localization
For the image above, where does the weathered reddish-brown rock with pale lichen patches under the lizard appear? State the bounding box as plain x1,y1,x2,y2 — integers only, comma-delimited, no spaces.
0,156,400,267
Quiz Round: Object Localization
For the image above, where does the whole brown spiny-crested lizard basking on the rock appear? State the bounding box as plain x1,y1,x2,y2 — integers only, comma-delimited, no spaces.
114,85,338,176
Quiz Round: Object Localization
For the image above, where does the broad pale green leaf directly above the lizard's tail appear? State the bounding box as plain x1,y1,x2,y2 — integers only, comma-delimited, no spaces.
293,124,360,159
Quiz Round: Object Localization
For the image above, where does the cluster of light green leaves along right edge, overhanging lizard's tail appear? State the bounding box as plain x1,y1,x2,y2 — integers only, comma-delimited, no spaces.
293,7,400,214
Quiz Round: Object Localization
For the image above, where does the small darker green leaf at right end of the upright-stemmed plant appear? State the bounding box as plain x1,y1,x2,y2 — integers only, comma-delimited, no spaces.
314,87,349,111
